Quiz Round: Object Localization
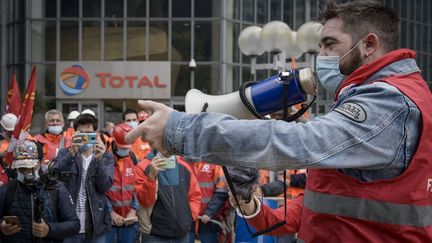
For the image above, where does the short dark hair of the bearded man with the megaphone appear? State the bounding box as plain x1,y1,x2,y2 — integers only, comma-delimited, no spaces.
320,0,400,52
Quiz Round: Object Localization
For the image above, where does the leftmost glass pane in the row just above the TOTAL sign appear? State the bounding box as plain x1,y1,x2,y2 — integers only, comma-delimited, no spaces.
31,21,57,61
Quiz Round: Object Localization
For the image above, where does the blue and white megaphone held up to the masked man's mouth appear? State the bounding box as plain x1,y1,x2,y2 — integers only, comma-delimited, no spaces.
185,68,316,119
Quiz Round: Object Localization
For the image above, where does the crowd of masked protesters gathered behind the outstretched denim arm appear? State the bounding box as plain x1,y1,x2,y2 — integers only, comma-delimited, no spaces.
0,109,300,243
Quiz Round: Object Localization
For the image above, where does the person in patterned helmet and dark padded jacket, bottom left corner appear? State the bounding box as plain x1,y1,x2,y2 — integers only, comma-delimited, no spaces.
0,140,79,243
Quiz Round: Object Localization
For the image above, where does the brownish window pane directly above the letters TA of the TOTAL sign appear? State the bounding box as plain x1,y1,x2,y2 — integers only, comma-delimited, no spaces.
126,21,147,60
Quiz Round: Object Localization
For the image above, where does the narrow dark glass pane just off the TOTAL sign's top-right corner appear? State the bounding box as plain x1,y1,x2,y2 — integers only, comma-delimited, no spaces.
171,21,191,61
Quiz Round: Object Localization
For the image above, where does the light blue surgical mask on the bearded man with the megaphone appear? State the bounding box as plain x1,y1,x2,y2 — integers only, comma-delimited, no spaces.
316,39,363,94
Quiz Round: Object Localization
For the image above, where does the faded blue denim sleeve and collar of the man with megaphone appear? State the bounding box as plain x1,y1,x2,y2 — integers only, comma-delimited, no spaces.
164,58,421,181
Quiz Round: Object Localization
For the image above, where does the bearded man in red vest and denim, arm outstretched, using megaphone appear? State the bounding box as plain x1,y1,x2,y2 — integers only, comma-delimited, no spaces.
126,0,432,242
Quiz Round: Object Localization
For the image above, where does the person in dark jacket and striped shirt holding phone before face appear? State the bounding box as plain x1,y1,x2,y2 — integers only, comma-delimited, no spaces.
53,114,114,243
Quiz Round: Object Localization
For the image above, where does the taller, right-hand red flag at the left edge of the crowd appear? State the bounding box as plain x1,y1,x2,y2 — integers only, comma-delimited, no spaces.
5,66,36,165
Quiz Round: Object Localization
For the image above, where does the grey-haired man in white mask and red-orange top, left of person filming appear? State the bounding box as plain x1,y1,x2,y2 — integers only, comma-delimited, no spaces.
35,110,71,170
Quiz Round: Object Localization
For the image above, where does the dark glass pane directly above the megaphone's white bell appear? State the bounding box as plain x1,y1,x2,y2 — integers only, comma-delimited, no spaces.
195,64,221,95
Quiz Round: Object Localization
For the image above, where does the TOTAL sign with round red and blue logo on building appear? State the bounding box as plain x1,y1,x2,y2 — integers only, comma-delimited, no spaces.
56,62,171,99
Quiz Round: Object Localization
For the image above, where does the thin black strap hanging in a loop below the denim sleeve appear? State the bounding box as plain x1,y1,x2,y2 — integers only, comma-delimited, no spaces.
222,166,287,238
